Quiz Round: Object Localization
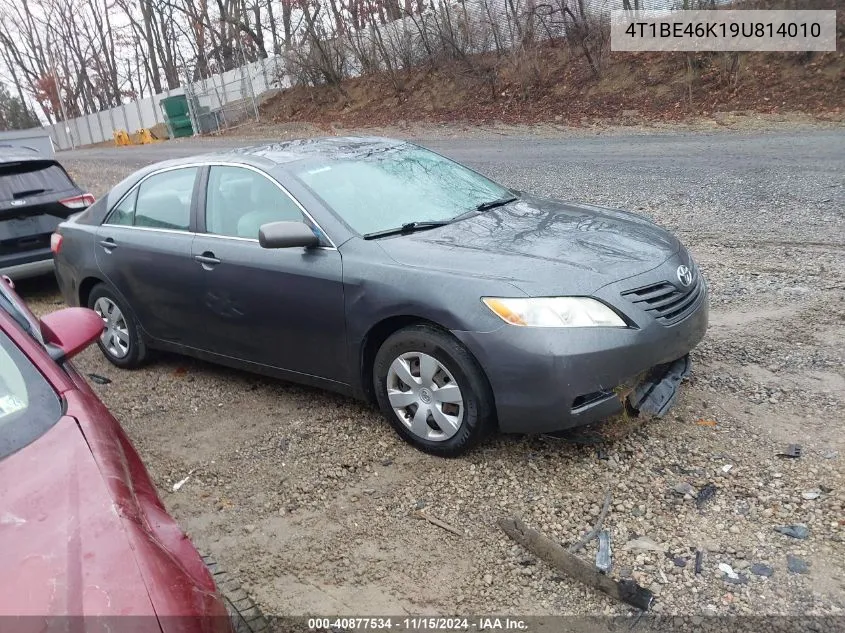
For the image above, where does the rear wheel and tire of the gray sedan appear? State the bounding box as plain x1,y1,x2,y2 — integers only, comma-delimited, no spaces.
88,283,147,369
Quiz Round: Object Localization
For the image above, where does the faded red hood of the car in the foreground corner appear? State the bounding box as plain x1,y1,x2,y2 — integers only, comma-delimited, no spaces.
0,416,156,616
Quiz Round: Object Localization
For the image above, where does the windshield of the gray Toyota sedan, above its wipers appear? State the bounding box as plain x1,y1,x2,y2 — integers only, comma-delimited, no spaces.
294,145,513,235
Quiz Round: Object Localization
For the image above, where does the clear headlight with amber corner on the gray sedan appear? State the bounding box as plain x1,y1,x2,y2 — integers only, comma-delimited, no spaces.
481,297,626,327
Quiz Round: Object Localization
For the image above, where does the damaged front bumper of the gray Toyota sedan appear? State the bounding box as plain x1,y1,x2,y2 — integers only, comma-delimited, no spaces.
453,288,708,434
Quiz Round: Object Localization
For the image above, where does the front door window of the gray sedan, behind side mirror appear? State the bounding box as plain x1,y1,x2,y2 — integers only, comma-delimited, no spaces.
205,165,305,239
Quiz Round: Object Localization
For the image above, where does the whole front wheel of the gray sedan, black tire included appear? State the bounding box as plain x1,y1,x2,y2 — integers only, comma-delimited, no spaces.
373,325,495,457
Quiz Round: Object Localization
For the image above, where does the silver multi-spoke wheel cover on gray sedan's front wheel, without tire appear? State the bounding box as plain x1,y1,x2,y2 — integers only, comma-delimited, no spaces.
387,352,464,442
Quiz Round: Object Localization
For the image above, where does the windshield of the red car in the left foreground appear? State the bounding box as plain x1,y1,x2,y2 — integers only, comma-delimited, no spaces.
0,331,62,459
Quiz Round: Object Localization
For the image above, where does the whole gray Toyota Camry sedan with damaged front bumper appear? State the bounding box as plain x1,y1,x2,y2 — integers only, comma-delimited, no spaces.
52,138,708,456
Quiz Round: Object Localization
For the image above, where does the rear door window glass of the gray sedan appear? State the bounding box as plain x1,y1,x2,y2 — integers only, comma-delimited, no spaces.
106,167,199,231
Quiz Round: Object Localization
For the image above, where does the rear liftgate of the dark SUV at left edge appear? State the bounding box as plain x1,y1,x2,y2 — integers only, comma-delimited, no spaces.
0,160,80,267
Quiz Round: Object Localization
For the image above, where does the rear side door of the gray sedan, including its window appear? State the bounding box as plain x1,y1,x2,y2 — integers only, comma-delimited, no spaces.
95,167,200,346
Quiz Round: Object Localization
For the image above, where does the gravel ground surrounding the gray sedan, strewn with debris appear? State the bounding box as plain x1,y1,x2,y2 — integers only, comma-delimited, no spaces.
19,127,845,617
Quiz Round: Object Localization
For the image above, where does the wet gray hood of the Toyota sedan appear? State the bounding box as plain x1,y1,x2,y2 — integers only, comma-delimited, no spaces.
378,197,680,295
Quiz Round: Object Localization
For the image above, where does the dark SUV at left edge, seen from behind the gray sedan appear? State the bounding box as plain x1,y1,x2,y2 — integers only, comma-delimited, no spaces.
0,145,94,279
